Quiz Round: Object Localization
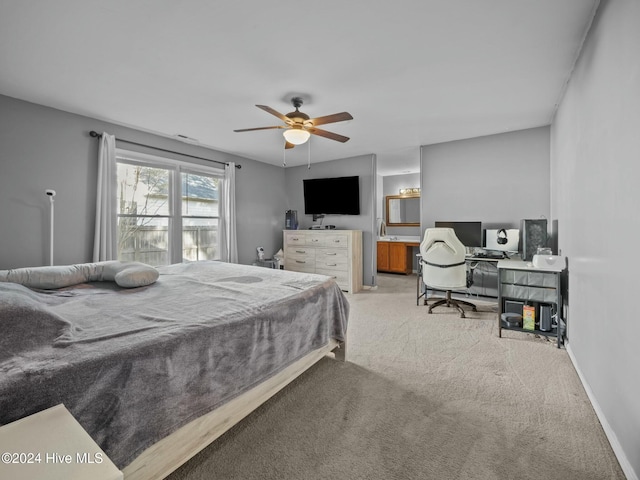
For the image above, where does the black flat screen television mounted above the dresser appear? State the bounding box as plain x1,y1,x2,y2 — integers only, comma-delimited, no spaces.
303,176,360,215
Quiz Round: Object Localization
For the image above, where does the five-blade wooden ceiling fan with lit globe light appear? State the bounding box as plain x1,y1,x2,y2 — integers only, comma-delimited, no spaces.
234,97,353,148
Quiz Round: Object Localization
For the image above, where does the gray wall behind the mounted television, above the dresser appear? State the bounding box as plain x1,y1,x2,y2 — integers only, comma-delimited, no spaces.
281,155,377,286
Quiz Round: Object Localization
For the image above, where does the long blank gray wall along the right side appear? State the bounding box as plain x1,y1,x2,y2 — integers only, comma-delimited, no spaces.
551,0,640,480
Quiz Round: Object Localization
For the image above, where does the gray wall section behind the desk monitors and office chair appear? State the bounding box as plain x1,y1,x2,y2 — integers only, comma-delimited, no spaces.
420,127,550,232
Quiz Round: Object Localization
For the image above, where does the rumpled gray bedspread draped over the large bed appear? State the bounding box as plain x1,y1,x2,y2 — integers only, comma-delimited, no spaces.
0,262,349,468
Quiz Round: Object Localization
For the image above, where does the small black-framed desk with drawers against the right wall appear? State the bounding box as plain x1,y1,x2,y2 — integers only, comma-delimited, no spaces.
498,260,566,348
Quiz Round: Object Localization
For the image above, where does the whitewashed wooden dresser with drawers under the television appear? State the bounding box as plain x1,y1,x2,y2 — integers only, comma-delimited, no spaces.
283,230,362,293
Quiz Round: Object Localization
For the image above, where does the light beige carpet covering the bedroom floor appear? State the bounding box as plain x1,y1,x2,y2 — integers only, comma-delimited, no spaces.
168,274,625,480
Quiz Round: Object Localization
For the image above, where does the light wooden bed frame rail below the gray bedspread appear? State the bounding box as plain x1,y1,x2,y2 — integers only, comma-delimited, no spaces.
123,340,346,480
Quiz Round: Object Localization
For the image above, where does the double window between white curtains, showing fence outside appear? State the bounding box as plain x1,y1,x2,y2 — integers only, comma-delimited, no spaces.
116,150,223,265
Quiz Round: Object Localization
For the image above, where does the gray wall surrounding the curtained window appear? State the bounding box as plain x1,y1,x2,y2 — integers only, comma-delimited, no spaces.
0,95,286,269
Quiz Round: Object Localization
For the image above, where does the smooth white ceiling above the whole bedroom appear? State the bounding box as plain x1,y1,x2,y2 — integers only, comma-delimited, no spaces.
0,0,598,175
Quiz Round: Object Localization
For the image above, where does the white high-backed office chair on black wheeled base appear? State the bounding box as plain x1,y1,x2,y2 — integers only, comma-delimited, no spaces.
420,228,478,318
